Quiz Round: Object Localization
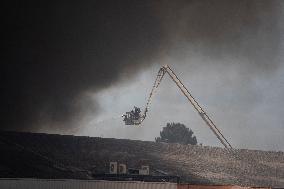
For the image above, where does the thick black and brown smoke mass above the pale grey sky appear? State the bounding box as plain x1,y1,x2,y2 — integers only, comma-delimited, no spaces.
0,0,279,130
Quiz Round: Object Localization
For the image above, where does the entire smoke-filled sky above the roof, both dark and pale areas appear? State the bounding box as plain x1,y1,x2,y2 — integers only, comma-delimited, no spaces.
0,0,284,151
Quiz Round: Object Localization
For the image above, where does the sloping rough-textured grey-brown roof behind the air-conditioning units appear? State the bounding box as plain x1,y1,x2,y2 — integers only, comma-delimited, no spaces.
0,131,284,187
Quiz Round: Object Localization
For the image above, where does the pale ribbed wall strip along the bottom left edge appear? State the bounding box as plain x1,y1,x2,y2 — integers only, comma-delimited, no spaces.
0,179,177,189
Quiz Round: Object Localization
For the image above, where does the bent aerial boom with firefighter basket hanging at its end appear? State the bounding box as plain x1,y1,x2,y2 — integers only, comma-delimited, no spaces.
123,65,232,148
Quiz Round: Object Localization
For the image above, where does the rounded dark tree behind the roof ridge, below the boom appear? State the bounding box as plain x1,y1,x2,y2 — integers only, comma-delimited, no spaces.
155,123,197,145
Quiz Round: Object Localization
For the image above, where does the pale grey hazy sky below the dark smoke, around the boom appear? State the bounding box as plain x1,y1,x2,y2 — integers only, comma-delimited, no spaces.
74,55,284,151
